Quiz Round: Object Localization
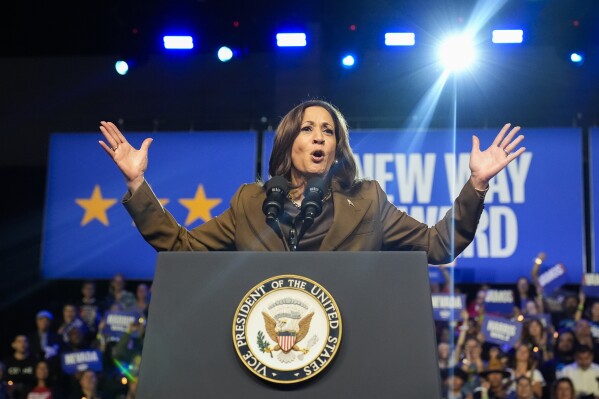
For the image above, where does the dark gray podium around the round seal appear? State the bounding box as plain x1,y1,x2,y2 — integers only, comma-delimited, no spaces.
138,252,440,399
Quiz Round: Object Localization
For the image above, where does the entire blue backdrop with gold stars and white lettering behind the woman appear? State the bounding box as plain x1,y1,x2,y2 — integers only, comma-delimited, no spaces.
42,128,584,283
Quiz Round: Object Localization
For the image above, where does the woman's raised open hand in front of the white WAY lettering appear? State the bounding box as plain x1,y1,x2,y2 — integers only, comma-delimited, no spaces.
470,123,526,190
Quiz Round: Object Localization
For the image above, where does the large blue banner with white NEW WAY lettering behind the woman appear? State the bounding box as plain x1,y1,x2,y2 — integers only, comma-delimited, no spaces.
262,128,580,283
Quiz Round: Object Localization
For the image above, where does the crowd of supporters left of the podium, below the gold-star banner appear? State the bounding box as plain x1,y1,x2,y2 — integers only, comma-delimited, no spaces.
0,274,150,399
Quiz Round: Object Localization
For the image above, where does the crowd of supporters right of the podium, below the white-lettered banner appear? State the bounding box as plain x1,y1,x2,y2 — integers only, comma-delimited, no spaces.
433,254,599,399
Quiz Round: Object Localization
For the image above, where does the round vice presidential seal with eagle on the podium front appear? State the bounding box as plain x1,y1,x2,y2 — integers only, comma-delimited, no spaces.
233,275,341,384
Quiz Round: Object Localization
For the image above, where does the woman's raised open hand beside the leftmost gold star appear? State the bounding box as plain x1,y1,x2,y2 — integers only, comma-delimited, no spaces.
99,121,152,193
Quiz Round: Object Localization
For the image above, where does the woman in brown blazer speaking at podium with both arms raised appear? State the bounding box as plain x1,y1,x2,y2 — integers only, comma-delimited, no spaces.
100,100,525,264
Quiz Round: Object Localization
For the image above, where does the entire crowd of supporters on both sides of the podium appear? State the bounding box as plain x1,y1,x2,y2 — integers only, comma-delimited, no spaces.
0,253,599,399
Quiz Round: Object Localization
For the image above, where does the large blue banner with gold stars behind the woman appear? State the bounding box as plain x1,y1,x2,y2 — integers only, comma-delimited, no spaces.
42,131,256,279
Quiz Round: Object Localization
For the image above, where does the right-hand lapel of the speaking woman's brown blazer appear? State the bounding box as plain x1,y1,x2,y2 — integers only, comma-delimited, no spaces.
320,185,372,251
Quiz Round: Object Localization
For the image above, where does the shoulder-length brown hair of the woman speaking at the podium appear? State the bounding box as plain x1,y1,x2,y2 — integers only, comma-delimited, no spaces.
268,100,357,191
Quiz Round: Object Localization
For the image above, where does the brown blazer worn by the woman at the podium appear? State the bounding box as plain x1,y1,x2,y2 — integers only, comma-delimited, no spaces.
123,181,484,263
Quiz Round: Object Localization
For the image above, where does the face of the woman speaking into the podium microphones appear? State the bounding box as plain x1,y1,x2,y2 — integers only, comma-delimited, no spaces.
291,106,337,184
